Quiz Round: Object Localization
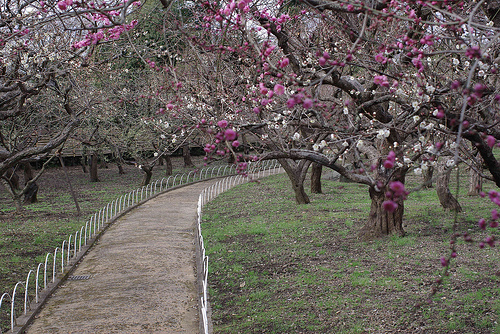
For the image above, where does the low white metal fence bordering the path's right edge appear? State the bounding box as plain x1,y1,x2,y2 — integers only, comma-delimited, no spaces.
197,160,283,334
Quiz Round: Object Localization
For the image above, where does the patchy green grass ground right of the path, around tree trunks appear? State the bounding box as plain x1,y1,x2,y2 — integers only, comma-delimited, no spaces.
202,171,500,334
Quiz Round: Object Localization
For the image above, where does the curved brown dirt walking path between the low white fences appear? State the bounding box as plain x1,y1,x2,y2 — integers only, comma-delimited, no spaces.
26,180,217,334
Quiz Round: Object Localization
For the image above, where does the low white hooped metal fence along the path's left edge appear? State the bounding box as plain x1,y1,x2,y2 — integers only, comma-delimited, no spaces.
0,161,275,334
